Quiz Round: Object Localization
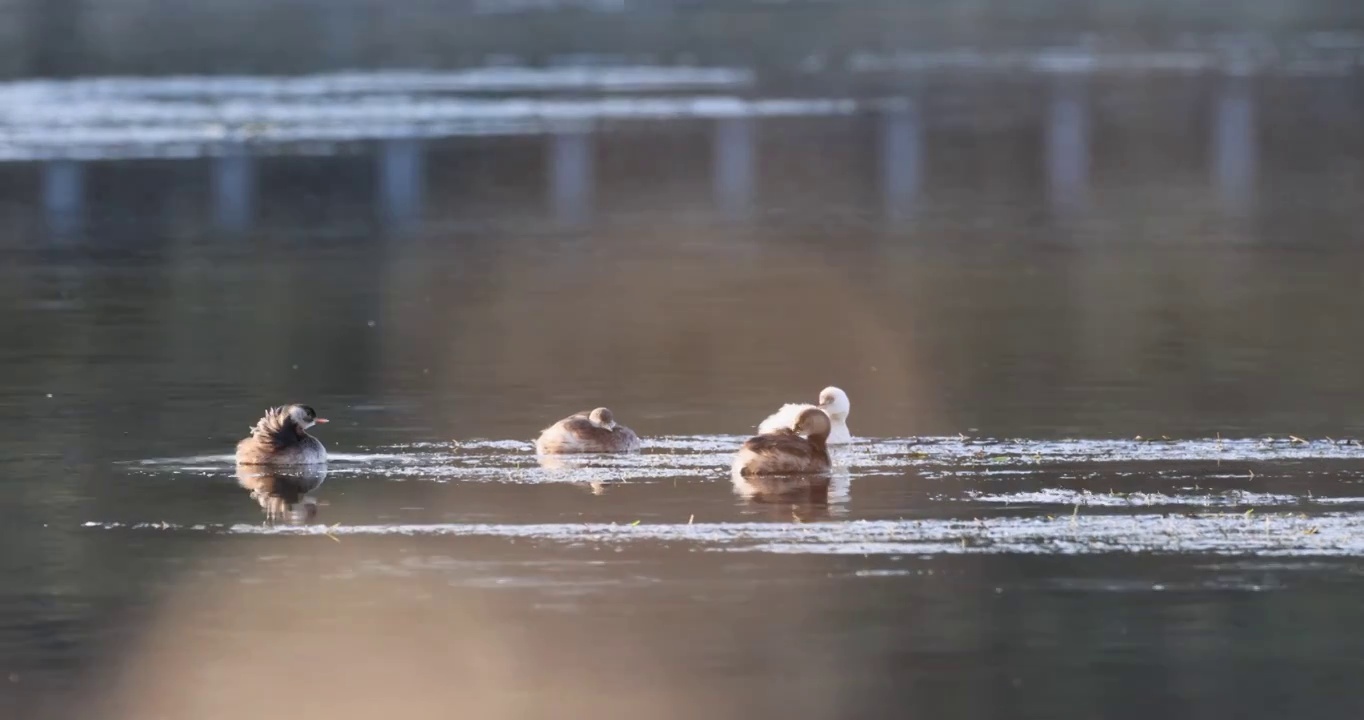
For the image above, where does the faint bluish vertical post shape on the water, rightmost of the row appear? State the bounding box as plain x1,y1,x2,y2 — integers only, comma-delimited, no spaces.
1213,74,1256,215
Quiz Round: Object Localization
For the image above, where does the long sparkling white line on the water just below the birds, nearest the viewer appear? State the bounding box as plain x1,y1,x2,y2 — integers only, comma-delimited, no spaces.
85,513,1364,556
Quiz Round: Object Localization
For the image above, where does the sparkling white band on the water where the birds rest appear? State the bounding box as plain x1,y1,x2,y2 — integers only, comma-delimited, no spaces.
124,435,1364,485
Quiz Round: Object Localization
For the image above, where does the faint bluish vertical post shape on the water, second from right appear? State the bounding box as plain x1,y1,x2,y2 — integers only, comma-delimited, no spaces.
1046,72,1090,213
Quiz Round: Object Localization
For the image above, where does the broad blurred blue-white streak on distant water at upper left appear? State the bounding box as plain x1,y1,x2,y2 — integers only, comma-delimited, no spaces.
0,95,861,161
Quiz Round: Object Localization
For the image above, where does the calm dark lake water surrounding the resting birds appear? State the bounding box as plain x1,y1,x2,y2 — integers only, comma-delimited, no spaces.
0,62,1364,719
